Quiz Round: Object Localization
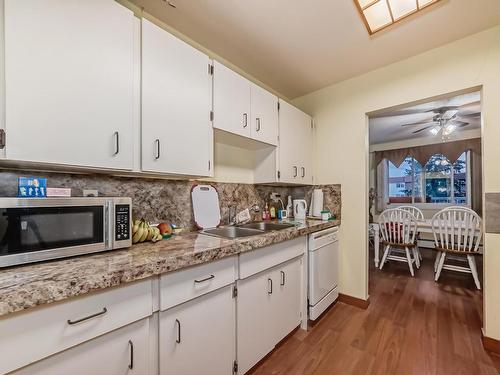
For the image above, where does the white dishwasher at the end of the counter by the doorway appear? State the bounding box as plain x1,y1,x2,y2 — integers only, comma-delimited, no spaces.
308,227,339,320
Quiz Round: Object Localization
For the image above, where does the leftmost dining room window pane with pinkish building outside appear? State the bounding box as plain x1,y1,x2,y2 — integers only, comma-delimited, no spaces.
389,157,413,203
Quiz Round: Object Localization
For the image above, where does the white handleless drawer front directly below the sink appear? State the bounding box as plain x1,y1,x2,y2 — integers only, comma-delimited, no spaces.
240,236,307,279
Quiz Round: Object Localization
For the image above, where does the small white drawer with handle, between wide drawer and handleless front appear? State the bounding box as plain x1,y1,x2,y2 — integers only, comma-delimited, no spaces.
160,256,237,311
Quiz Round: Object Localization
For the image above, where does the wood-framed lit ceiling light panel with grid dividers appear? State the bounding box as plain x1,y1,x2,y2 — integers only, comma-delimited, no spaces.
354,0,441,35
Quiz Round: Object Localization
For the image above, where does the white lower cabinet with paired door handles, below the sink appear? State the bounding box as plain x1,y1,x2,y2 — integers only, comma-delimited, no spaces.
236,258,302,374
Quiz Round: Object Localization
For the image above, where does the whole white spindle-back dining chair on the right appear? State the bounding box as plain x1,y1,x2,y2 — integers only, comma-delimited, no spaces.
431,207,483,289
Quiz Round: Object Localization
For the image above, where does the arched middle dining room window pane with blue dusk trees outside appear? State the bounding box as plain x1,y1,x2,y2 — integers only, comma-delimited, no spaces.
425,154,451,203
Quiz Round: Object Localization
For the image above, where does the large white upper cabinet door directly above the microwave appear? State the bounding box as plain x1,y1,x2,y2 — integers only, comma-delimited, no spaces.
5,0,135,169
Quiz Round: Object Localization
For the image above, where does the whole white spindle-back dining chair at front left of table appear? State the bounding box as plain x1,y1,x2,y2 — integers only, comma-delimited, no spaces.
379,208,420,276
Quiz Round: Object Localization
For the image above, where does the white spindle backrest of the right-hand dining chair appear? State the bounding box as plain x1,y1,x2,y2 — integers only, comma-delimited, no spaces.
431,207,483,252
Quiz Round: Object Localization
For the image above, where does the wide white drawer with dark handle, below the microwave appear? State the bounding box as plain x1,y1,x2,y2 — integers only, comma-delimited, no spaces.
0,279,152,374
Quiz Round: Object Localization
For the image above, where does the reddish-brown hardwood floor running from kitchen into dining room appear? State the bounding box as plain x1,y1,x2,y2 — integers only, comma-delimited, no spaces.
252,249,500,375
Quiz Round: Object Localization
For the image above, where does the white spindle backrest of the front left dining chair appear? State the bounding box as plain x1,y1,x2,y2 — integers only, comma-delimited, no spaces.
378,208,417,245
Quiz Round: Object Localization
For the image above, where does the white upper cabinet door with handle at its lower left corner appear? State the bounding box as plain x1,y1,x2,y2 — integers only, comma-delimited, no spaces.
142,19,213,176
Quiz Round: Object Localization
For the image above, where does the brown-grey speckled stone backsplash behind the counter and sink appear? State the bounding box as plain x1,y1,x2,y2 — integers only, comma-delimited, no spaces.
0,170,341,229
